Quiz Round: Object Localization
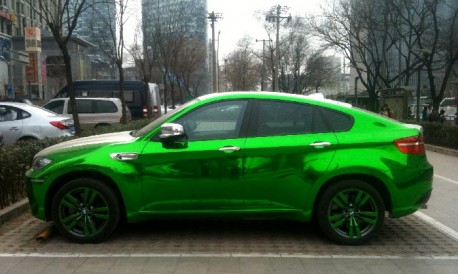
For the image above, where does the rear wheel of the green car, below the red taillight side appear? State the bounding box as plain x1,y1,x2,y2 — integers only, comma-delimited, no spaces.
317,180,385,245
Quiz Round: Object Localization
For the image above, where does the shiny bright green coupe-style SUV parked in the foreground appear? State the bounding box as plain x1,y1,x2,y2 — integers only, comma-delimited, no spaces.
26,92,433,245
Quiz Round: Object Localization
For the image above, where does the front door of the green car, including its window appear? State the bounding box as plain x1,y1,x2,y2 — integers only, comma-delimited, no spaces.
139,100,248,212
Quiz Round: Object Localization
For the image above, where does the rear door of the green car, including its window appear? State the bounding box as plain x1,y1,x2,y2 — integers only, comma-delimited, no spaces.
240,100,337,210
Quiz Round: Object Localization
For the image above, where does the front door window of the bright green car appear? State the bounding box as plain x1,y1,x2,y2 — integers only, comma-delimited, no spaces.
175,101,247,141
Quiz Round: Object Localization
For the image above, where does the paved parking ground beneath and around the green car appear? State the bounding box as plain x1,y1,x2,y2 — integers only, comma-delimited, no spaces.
0,151,458,274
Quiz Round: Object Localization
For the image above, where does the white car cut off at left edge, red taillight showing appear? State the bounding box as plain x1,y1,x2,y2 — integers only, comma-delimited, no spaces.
0,102,75,145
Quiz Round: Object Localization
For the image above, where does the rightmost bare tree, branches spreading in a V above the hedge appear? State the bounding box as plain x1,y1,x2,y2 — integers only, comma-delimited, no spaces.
391,0,458,115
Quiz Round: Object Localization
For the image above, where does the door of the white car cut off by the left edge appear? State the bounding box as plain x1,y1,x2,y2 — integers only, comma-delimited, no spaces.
0,105,23,145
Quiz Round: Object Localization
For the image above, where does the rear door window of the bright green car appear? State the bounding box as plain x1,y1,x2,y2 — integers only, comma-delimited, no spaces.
250,101,329,136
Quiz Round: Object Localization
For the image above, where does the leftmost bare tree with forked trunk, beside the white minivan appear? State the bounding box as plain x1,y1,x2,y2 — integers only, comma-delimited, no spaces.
28,0,101,135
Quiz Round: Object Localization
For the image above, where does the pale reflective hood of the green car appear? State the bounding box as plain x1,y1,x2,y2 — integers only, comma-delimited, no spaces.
36,131,137,156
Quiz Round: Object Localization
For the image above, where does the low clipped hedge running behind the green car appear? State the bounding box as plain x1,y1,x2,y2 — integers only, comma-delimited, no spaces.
0,120,458,209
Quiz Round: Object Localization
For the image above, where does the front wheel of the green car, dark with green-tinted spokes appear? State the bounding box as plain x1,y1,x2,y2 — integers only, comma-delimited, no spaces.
52,178,120,243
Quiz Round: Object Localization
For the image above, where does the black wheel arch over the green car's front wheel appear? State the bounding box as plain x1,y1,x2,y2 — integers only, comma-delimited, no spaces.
45,170,126,221
